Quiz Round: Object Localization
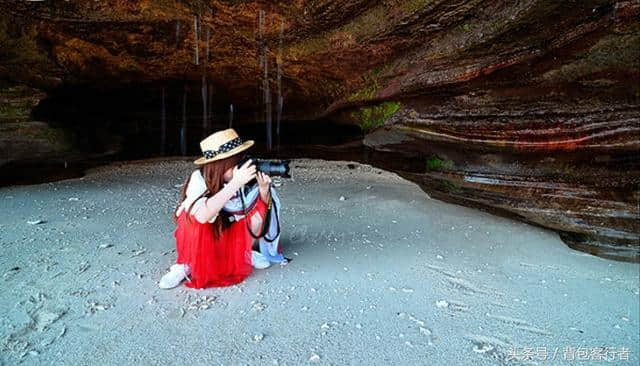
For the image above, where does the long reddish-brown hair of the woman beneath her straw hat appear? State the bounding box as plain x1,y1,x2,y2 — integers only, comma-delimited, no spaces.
173,152,245,239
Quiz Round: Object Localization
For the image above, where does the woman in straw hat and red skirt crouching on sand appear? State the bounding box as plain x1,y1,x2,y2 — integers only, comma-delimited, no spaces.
159,129,271,289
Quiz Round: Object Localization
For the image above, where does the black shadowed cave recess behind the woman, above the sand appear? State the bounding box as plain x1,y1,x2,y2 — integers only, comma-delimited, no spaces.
5,84,432,185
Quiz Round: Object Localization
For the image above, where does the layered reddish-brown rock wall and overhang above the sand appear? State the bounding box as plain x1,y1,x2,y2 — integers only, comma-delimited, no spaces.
0,0,640,260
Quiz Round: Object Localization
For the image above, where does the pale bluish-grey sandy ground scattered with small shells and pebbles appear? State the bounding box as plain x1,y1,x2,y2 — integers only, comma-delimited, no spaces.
0,159,640,365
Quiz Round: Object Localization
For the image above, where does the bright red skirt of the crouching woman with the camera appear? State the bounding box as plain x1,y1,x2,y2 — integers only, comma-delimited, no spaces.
174,197,267,289
